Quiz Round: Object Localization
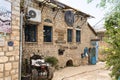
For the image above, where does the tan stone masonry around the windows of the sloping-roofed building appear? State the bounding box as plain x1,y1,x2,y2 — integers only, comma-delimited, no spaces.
23,3,95,67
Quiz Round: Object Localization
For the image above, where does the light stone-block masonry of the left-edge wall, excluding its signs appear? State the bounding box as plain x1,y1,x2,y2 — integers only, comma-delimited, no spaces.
0,0,20,80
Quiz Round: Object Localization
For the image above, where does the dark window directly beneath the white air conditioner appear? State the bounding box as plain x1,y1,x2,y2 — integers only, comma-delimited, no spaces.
25,24,37,42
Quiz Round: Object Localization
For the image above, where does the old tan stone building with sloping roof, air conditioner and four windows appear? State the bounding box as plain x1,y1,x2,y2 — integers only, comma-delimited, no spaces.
23,0,96,67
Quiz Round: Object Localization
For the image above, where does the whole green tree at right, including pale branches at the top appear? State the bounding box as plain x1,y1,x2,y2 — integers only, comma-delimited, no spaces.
88,0,120,80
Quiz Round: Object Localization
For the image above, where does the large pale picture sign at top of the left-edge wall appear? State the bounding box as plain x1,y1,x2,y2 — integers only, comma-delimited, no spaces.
0,0,12,33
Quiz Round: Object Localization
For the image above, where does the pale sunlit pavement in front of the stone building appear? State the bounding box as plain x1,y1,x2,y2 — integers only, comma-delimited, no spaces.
52,62,112,80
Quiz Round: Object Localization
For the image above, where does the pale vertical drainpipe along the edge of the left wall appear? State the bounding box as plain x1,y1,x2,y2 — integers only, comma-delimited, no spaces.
19,12,23,80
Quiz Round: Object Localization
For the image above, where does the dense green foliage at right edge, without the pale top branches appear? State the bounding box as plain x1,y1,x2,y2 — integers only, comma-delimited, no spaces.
105,11,120,80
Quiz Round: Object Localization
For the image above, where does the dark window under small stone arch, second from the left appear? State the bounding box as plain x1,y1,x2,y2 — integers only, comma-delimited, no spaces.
44,26,52,42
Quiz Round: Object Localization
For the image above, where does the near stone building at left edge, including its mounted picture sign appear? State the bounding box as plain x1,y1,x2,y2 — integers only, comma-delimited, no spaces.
0,0,20,80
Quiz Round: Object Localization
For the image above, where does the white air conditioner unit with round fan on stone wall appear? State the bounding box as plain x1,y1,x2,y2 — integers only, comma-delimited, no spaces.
28,7,41,22
